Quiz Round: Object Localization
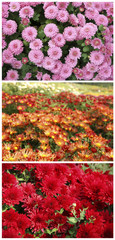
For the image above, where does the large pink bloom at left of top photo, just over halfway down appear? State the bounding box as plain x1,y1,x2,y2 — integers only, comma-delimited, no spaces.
8,39,23,55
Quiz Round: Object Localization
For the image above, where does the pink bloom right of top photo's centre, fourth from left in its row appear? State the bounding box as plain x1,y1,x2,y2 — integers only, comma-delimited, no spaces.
63,27,77,42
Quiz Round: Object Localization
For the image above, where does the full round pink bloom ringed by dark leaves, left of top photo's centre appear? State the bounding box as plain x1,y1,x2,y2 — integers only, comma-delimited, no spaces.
22,27,37,42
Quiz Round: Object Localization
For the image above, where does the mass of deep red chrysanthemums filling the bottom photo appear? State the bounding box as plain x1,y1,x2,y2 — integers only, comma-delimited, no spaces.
2,163,113,238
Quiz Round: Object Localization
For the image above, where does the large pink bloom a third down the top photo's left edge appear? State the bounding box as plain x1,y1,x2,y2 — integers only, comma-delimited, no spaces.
3,20,17,35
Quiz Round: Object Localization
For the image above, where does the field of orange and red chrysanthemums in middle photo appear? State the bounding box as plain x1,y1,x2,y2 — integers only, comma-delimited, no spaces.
2,92,113,161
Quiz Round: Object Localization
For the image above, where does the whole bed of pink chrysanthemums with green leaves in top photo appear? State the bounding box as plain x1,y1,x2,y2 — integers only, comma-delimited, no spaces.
2,2,113,80
